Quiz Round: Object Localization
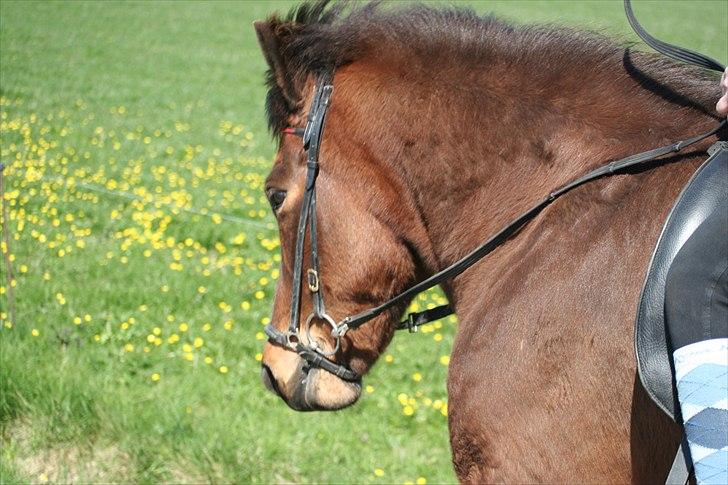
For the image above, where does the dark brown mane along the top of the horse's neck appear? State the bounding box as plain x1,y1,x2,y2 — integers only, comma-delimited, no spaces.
258,0,717,134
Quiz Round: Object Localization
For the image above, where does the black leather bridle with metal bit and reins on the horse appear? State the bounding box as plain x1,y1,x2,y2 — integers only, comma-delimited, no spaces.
265,0,726,381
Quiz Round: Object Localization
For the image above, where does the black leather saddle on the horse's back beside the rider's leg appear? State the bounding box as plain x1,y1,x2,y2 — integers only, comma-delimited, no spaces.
635,141,728,420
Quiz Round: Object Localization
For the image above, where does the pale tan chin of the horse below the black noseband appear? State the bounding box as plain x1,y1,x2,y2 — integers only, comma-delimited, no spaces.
287,368,361,411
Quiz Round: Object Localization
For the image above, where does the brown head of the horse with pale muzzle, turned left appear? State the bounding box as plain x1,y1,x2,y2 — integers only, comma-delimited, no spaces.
255,4,432,410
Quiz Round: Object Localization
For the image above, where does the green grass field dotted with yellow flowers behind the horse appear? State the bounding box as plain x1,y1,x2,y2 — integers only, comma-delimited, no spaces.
0,1,728,483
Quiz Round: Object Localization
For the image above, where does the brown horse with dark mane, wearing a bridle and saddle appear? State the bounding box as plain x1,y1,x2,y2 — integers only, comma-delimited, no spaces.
255,3,726,482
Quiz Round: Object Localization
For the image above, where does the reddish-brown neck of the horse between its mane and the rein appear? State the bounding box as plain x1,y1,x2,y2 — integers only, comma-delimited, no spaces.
334,54,715,288
